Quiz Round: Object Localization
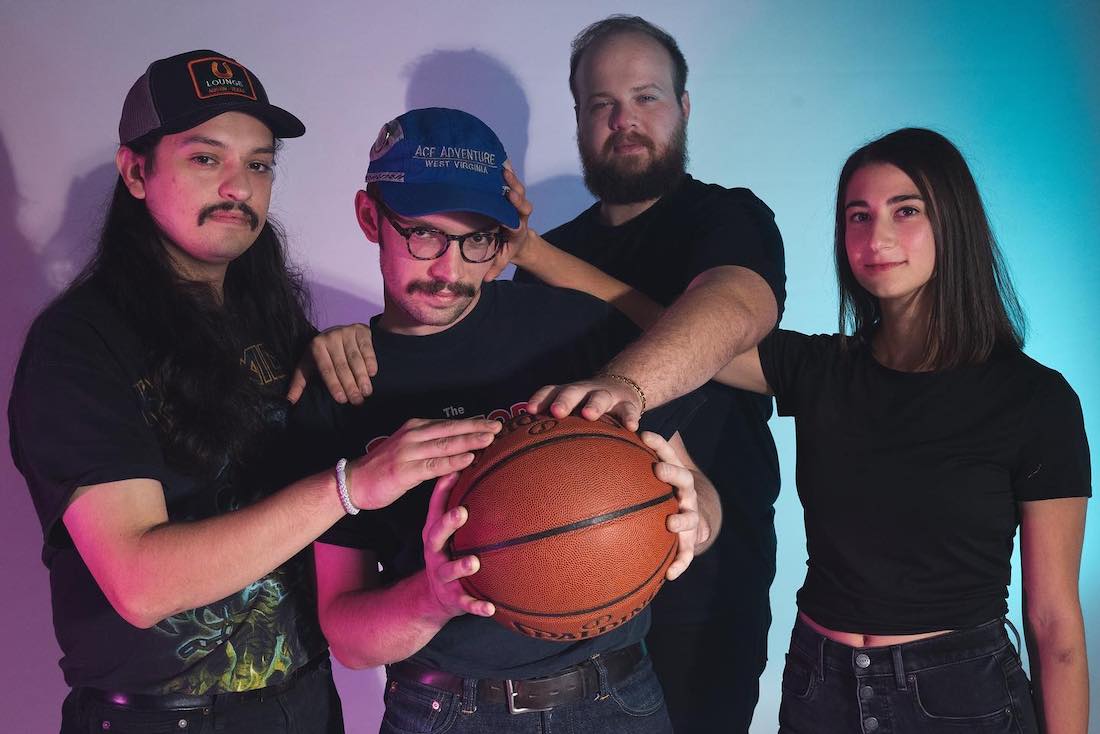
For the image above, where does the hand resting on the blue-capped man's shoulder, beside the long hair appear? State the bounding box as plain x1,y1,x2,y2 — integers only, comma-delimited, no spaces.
286,324,378,405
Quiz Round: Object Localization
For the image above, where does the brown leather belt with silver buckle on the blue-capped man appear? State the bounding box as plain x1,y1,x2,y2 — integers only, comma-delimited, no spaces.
386,643,646,713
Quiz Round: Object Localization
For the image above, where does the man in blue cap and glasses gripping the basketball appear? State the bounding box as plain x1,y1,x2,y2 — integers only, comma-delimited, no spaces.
292,108,717,734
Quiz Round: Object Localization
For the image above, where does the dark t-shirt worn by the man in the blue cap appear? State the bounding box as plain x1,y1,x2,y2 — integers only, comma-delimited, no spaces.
292,282,699,679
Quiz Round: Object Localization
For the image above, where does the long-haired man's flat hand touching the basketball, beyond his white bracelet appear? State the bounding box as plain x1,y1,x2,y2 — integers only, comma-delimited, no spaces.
348,418,501,510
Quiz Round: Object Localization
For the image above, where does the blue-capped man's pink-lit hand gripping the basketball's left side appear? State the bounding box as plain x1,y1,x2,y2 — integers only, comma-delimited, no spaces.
424,473,496,624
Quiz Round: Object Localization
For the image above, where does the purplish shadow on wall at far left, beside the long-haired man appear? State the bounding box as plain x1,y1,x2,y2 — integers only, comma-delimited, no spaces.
0,130,118,732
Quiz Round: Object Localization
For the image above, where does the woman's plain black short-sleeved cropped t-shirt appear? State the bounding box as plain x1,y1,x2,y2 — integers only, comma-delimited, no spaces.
760,330,1091,635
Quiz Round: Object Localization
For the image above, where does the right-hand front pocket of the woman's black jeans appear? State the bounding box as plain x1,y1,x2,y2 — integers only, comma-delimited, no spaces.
909,655,1012,725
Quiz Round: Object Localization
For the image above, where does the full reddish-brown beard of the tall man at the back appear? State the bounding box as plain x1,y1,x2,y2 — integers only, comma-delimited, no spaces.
578,119,688,204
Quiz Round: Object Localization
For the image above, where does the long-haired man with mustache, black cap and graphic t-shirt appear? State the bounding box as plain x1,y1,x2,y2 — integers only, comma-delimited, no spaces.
9,51,498,733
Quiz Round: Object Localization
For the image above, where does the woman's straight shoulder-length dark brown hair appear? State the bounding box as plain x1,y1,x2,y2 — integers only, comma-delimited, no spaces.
835,128,1025,370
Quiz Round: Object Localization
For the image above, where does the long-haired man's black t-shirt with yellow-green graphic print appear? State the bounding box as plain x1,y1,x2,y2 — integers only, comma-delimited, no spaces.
9,279,325,693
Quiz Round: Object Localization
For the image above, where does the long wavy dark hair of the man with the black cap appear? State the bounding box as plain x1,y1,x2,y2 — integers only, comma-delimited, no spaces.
69,138,312,476
